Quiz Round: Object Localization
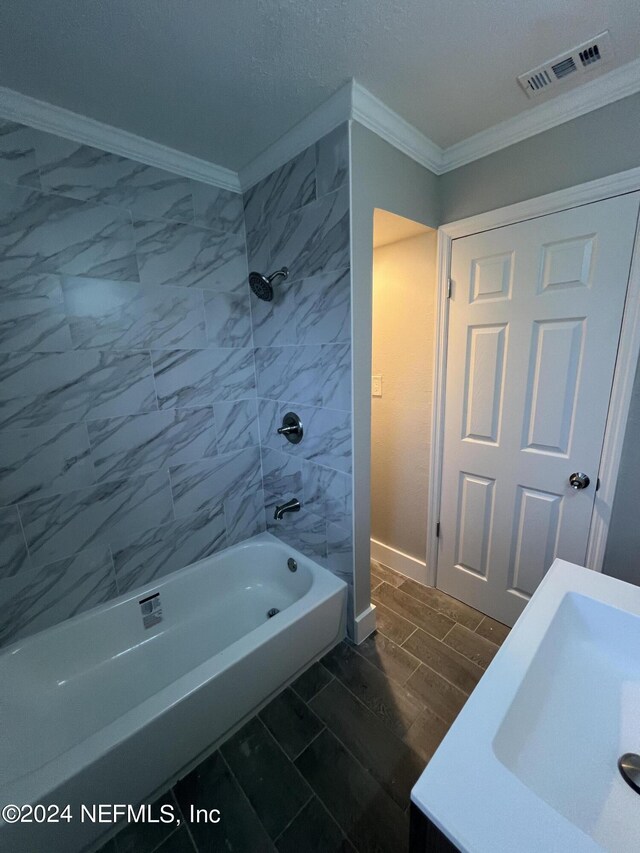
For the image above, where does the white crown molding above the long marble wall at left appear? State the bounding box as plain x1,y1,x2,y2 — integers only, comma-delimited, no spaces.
0,87,240,192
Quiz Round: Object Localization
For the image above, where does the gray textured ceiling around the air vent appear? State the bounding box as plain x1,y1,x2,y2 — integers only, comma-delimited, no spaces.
0,0,640,170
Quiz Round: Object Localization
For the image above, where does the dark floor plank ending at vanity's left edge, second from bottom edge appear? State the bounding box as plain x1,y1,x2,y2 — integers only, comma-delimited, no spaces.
311,679,424,809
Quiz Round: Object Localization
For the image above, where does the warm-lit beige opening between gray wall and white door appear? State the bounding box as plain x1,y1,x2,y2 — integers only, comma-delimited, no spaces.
371,209,437,584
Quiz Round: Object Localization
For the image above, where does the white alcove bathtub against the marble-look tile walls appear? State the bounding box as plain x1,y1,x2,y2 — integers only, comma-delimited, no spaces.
0,533,346,853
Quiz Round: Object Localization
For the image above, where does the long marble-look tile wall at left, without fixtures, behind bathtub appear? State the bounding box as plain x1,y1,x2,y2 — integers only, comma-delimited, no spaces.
0,116,262,643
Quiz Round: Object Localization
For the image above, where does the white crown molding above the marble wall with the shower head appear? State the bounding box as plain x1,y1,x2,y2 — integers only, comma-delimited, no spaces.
239,80,353,192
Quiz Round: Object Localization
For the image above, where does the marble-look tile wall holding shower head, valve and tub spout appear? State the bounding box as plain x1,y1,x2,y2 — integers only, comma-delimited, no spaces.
244,124,353,622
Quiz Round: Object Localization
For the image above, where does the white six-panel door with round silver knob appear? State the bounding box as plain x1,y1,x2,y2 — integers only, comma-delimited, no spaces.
437,193,639,624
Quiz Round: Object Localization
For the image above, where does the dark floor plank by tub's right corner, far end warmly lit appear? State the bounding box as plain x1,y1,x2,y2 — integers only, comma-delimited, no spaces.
323,643,422,737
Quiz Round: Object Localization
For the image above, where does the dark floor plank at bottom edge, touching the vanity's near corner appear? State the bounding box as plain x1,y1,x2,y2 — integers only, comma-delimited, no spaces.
295,729,409,853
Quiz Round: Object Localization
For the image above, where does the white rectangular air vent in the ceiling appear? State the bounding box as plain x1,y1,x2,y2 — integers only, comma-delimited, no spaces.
518,30,613,98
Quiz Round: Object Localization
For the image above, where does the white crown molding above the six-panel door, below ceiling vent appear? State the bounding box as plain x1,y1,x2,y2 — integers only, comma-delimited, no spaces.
438,59,640,174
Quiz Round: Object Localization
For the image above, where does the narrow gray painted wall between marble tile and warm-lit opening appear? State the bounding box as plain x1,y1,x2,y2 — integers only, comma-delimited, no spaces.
351,122,440,617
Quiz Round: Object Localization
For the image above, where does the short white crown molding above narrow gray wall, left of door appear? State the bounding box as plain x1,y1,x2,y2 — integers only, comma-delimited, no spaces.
351,80,444,175
